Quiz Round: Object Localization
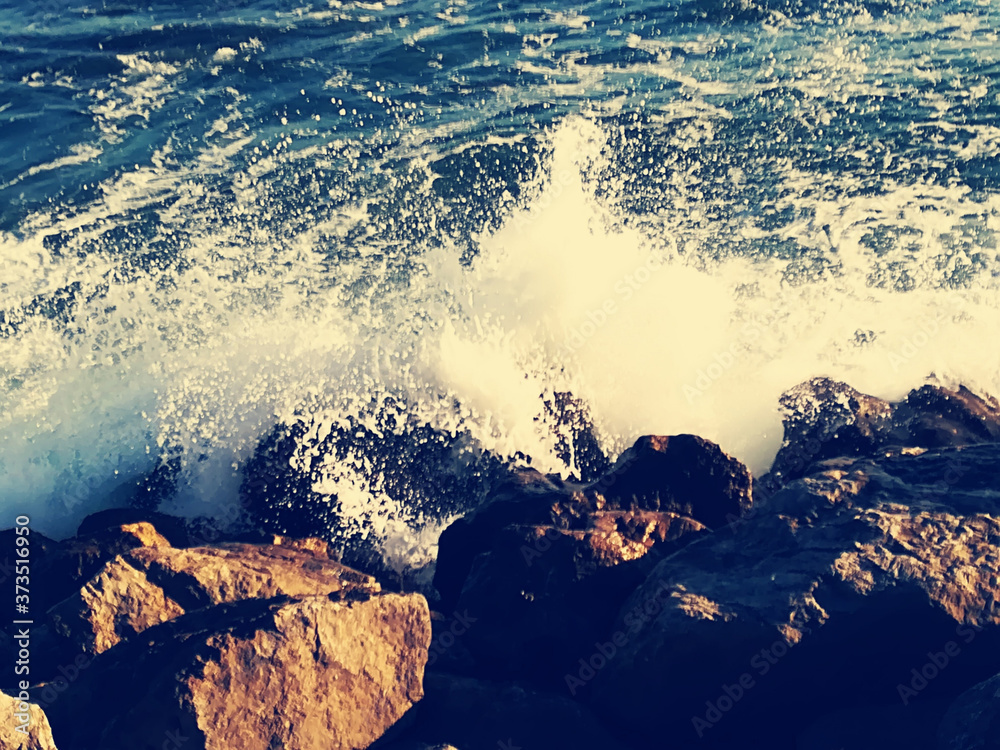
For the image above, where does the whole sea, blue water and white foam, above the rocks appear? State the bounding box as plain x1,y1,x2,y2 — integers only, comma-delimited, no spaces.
0,0,1000,556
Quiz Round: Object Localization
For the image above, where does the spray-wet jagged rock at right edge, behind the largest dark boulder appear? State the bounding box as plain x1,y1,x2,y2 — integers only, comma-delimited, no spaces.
763,378,1000,489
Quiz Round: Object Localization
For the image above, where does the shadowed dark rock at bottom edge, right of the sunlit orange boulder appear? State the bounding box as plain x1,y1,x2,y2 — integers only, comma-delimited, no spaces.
407,673,623,750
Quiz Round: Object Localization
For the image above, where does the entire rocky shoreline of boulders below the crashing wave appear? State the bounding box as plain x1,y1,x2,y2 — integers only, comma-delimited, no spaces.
0,379,1000,750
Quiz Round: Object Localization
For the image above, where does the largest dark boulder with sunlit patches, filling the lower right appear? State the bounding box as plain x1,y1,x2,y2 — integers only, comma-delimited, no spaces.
581,444,1000,747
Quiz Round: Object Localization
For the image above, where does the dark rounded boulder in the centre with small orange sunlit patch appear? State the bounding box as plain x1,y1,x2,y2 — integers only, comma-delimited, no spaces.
435,435,751,688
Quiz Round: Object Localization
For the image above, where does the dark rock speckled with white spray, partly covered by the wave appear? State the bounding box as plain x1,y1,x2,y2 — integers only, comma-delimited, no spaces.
240,406,506,580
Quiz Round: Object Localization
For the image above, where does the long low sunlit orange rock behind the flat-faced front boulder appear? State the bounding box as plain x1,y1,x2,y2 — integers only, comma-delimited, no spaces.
49,536,379,654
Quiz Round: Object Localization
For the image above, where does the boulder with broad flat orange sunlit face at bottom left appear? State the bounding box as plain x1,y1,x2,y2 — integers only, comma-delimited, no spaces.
50,594,430,750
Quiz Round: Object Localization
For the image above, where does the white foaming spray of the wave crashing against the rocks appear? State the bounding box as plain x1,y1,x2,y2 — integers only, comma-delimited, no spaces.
0,118,1000,572
